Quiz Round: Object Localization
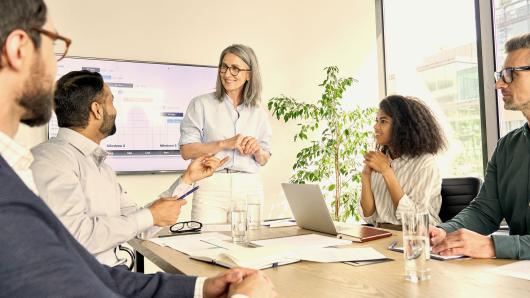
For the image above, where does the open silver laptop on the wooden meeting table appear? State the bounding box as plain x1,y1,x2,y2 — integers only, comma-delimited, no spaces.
282,183,392,242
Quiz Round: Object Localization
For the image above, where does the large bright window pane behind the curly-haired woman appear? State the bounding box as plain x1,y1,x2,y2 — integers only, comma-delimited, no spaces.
382,0,482,177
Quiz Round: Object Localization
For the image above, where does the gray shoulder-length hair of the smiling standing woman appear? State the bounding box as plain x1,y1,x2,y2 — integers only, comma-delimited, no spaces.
211,44,261,107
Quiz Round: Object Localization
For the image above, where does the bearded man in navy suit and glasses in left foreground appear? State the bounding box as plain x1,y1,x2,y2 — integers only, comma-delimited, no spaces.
0,0,275,297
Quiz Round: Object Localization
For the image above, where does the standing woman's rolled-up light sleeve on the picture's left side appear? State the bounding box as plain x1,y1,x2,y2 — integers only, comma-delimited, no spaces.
179,98,204,146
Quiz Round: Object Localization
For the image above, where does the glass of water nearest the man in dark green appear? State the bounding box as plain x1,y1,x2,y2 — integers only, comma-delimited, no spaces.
401,212,431,282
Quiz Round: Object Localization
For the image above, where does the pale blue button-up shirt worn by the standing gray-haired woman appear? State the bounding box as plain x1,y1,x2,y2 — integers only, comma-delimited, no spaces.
179,93,272,173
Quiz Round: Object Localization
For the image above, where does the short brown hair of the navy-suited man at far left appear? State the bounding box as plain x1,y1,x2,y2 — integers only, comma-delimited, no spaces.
0,0,48,60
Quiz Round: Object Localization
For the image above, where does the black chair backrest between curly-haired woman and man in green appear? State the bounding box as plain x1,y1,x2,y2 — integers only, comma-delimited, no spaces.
440,177,482,222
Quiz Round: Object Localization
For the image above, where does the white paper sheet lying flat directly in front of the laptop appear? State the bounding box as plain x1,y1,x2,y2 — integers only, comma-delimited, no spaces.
251,234,352,248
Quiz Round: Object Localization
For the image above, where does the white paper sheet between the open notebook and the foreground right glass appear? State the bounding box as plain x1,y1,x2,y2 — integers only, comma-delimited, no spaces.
297,247,387,263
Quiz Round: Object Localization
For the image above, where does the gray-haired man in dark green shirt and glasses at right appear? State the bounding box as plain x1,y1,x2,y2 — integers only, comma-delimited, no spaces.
429,34,530,259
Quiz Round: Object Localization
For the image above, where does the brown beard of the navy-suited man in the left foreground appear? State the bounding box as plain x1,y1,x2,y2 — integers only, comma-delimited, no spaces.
17,59,54,126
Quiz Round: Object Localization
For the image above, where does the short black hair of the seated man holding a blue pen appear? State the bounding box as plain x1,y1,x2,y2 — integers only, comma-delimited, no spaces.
55,70,105,128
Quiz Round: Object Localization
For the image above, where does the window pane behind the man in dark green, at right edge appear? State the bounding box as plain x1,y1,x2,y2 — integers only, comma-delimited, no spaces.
493,0,530,136
